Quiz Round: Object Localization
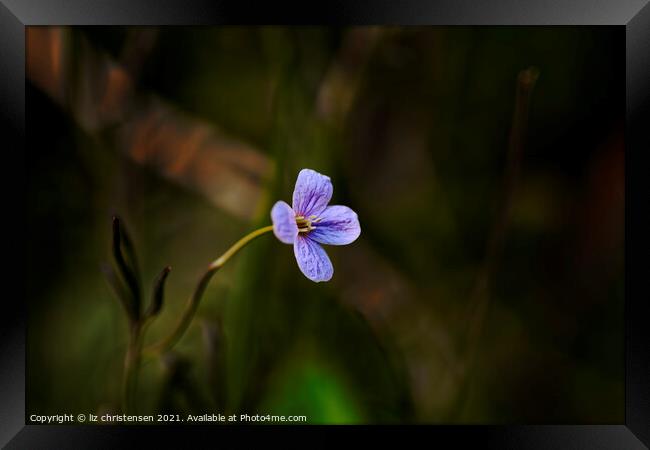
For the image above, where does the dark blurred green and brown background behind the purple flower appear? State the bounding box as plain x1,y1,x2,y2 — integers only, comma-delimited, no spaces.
26,27,625,423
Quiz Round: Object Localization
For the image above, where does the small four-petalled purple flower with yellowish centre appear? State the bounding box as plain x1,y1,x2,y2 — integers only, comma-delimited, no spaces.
271,169,361,282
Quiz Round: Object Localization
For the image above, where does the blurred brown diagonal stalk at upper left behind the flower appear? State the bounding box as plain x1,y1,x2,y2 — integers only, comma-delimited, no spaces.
27,27,273,219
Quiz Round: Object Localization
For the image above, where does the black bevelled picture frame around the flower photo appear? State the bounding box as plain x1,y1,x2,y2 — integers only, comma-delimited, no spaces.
0,0,650,449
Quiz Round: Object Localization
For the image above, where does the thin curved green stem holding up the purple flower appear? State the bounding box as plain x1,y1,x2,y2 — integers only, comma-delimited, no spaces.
144,225,273,355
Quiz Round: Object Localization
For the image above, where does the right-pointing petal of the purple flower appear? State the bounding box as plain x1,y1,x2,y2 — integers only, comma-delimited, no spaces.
309,205,361,245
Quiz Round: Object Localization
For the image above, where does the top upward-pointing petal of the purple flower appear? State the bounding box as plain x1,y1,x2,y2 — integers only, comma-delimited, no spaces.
293,169,334,217
